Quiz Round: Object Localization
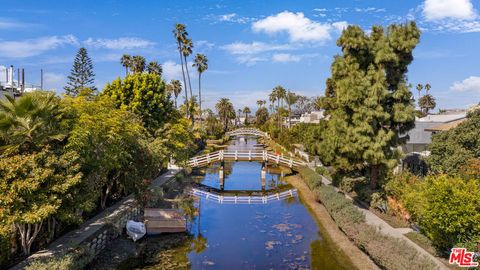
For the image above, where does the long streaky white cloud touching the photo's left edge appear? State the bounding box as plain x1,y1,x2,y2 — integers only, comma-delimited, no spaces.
0,35,78,58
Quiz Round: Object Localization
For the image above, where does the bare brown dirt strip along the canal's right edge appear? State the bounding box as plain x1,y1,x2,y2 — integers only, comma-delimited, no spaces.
285,175,379,270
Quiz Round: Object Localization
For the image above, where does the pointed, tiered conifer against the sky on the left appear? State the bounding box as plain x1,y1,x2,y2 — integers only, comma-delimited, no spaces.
64,48,97,96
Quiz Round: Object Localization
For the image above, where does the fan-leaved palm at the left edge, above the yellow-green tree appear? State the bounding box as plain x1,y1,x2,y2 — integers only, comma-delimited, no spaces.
0,92,66,153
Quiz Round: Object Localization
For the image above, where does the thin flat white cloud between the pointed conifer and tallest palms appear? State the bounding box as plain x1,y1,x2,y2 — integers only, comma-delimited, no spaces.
83,37,155,50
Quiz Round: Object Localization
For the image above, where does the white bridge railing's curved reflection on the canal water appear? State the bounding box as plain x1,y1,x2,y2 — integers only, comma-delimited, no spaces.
190,188,297,204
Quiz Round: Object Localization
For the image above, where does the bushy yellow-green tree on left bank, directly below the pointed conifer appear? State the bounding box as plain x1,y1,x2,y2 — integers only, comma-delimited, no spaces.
66,96,154,210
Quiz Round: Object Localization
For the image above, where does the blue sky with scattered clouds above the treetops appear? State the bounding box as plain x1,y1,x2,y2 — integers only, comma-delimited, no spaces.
0,0,480,108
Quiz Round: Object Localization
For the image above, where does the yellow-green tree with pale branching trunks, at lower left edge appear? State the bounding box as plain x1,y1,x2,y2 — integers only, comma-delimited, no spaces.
0,147,81,255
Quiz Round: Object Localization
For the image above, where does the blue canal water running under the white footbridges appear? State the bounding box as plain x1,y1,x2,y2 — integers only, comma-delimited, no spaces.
135,137,352,270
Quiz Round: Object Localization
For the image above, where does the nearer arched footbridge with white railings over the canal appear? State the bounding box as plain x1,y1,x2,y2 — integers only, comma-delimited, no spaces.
187,150,307,168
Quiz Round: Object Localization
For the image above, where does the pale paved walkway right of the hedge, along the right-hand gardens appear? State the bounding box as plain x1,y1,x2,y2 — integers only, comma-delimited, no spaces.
311,167,449,269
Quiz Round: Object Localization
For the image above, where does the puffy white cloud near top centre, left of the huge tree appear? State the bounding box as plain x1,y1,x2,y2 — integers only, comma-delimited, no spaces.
252,11,345,42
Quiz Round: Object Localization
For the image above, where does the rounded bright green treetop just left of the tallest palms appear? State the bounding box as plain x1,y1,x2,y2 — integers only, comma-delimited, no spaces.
102,73,175,131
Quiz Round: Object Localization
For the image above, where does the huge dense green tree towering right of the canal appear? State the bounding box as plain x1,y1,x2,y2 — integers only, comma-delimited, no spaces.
321,22,420,189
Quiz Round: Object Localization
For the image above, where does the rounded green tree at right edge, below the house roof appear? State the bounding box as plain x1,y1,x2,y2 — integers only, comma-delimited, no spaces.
426,114,480,174
